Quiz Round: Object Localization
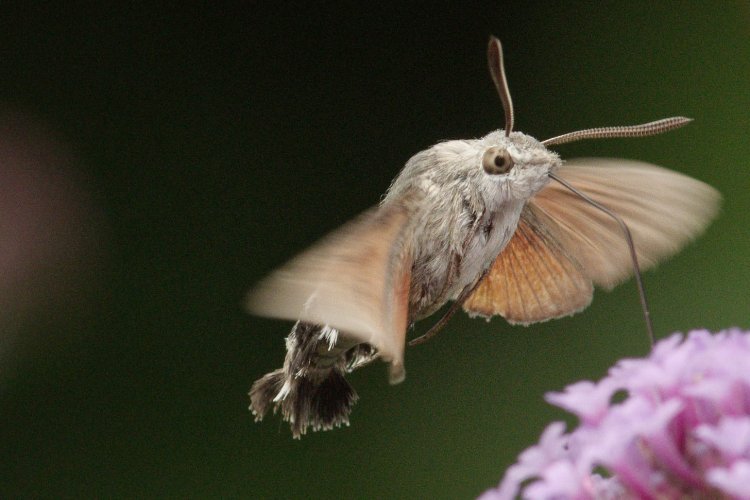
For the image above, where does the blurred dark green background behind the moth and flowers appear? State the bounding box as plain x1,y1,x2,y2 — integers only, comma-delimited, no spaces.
0,1,750,498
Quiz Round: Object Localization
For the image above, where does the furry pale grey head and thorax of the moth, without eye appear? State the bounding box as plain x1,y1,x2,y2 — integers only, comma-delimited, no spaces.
383,130,561,321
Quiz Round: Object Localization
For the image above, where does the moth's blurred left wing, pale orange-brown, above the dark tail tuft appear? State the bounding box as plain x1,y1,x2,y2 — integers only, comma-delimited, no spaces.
248,203,418,383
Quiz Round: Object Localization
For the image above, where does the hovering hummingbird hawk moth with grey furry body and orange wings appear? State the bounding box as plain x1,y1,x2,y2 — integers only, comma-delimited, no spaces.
248,37,720,438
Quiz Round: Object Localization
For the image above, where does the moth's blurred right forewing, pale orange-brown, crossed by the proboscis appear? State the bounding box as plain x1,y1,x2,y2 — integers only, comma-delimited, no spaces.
529,158,721,289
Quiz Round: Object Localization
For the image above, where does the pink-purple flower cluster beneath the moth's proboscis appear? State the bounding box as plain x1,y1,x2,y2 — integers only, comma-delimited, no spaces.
480,329,750,500
